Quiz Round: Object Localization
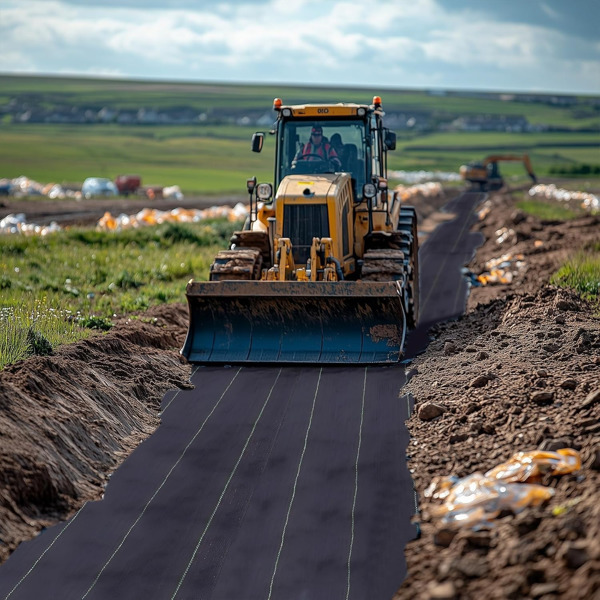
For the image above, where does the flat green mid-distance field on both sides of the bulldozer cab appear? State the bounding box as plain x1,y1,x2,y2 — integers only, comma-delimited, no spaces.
0,124,600,195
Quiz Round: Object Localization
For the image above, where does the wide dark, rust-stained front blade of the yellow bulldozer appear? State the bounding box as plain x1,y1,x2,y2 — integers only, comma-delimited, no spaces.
181,281,406,363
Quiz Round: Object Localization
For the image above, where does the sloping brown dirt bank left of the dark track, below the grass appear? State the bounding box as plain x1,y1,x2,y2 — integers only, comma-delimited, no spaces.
0,305,190,560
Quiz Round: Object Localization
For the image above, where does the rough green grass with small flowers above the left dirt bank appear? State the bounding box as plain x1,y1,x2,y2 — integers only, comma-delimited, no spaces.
0,219,241,368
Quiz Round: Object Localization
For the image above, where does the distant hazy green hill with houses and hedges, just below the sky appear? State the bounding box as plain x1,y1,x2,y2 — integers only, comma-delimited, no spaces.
0,75,600,132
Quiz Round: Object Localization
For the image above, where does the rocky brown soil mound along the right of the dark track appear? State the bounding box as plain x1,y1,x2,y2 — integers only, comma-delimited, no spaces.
395,189,600,600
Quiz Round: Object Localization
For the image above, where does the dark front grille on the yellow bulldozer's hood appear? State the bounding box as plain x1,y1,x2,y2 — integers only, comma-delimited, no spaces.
283,204,329,265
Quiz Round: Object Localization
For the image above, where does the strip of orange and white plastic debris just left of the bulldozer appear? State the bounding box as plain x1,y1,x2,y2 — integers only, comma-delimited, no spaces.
97,202,249,231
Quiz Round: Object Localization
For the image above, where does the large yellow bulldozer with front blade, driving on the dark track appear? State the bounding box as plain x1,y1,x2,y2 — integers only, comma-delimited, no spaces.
182,96,419,364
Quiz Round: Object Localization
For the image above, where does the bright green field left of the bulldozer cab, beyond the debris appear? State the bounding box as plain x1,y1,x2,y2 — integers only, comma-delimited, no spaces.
0,125,274,195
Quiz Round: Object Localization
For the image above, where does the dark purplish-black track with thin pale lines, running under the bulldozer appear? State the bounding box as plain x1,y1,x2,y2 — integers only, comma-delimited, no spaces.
0,193,482,600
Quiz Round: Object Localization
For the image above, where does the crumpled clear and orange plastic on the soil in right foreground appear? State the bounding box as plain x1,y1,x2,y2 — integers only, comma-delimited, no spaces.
424,448,581,528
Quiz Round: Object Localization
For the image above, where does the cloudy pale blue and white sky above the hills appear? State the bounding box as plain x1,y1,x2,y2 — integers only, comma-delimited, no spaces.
0,0,600,94
